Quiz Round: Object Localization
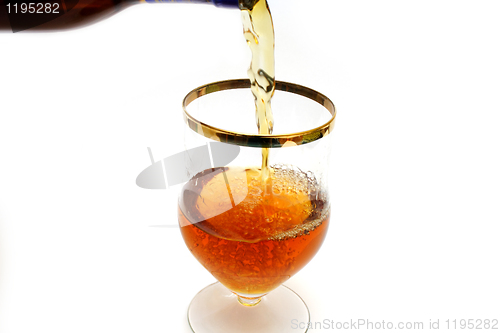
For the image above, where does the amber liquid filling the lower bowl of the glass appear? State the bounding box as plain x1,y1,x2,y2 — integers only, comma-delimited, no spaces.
179,166,330,298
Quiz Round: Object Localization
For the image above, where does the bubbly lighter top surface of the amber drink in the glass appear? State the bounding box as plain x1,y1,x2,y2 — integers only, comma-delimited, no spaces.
194,166,329,243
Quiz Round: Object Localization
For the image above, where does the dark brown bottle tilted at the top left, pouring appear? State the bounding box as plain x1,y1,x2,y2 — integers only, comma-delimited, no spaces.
0,0,239,33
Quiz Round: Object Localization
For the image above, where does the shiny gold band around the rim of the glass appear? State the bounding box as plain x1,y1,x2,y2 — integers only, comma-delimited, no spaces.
182,79,337,148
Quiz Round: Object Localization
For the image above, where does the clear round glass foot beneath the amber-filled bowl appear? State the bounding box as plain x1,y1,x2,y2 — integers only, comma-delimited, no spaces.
188,282,310,333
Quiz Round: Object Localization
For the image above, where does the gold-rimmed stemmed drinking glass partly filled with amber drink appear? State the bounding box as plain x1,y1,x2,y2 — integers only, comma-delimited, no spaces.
176,80,336,333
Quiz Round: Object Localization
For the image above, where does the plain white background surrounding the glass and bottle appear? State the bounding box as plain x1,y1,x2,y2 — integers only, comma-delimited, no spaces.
0,0,500,333
